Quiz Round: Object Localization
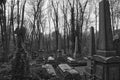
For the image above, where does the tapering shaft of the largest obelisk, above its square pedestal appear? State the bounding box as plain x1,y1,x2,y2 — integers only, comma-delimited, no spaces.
97,0,116,57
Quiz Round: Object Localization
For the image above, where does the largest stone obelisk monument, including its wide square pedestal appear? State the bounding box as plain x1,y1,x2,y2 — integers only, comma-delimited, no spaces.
93,0,120,80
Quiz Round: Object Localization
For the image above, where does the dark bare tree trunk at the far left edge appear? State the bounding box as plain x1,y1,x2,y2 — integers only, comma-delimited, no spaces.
0,0,9,61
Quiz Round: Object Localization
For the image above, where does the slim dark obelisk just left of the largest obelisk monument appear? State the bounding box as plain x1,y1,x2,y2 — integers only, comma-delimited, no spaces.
85,27,96,78
